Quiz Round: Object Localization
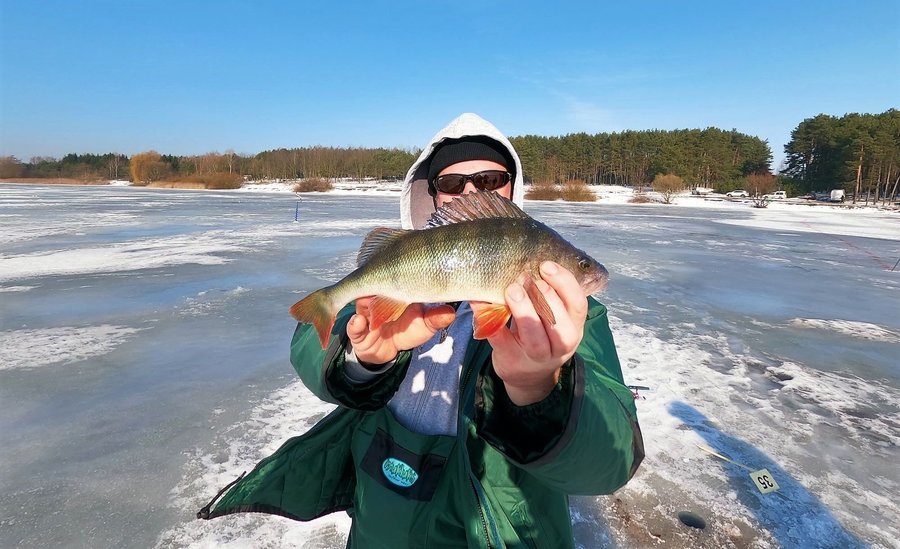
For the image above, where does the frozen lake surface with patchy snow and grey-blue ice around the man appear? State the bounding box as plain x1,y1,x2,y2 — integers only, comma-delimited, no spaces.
0,185,900,548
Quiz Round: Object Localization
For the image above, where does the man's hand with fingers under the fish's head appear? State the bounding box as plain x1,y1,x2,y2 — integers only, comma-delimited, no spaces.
488,261,588,406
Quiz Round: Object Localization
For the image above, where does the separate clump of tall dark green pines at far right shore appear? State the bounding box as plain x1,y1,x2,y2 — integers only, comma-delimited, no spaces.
783,109,900,200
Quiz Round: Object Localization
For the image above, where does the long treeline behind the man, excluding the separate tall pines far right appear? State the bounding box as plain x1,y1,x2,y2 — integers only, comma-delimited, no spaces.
0,128,772,186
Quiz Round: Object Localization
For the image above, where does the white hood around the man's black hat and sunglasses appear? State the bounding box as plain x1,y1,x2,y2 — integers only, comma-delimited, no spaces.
400,112,525,229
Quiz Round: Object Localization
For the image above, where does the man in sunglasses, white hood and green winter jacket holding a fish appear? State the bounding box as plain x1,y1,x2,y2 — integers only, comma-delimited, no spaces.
200,114,643,548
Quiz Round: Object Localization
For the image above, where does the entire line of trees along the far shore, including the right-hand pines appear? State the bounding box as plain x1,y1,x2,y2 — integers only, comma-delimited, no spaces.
0,109,900,195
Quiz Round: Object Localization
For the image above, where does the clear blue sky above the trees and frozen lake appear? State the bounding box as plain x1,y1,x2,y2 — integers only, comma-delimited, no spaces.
0,0,900,168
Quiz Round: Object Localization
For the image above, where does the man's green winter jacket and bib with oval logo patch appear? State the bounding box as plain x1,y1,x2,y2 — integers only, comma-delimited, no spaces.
198,298,643,549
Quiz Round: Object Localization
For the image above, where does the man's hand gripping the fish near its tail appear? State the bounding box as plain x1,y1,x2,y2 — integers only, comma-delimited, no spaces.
347,297,456,365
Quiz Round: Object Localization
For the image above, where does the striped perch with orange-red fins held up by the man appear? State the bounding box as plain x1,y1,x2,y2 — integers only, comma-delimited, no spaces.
291,192,608,347
